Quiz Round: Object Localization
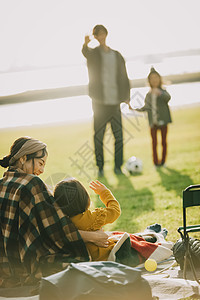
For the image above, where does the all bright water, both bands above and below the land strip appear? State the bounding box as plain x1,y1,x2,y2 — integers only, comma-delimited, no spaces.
0,56,200,128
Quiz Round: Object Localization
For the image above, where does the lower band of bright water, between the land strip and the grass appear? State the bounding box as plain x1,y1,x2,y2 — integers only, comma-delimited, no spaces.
0,82,200,128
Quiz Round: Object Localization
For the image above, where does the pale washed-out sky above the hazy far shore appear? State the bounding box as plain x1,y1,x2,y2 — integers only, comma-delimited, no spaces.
0,0,200,71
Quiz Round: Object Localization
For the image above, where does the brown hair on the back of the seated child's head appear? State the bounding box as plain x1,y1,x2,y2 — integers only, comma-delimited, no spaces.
54,178,90,217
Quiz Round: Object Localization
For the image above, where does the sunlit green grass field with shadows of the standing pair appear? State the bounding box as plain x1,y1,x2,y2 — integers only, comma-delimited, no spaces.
0,106,200,241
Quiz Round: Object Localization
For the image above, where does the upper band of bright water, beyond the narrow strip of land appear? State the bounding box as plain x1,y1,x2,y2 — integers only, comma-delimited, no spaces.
0,56,200,96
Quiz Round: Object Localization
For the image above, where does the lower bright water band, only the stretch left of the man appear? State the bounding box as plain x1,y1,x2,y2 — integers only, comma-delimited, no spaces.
0,96,92,128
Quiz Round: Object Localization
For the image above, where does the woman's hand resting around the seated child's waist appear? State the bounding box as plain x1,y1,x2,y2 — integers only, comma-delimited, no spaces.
79,229,109,248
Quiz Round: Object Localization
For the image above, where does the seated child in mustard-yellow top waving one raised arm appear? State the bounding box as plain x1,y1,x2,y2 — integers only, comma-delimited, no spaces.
54,178,172,267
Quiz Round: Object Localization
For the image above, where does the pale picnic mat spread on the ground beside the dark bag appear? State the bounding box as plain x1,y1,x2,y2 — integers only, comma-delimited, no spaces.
0,257,200,300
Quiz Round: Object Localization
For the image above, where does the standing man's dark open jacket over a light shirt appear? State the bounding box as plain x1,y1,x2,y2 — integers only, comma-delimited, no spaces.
82,45,130,104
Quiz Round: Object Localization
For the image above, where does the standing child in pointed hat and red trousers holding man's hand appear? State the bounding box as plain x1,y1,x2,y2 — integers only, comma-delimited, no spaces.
136,68,172,167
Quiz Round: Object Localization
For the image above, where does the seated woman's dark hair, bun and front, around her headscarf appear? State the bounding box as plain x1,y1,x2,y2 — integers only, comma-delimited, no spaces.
0,137,47,168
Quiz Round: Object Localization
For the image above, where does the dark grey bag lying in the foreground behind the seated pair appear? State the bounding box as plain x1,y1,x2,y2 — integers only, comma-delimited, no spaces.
40,261,153,300
